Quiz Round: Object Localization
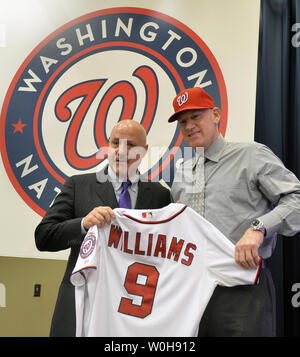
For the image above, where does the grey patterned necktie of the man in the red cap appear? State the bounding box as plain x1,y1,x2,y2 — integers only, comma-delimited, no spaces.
190,153,205,217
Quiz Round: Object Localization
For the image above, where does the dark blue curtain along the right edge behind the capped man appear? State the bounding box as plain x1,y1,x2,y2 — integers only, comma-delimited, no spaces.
255,0,300,337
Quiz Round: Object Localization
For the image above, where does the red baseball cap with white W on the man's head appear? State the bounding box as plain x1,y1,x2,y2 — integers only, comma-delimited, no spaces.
168,87,215,123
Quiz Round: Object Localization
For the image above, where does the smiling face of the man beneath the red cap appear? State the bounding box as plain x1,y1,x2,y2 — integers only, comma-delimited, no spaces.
178,107,221,150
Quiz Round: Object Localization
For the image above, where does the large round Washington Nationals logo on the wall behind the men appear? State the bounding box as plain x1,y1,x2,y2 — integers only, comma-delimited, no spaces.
0,8,227,215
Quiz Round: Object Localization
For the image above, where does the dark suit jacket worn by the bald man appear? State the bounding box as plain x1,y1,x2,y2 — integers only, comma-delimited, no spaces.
35,168,171,336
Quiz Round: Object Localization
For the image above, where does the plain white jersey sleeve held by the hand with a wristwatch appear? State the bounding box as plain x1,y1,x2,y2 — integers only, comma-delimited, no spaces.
206,225,261,286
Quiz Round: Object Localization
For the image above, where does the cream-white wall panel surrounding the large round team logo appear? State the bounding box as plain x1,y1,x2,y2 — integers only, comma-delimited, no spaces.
0,0,260,259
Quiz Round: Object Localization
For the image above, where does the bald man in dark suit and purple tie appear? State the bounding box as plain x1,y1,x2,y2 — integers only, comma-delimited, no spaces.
35,120,171,337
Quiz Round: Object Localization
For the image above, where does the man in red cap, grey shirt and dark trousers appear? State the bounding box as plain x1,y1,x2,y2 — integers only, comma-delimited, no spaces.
168,87,300,337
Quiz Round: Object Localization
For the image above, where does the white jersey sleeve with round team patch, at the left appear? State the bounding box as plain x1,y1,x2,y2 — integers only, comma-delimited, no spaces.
70,226,99,286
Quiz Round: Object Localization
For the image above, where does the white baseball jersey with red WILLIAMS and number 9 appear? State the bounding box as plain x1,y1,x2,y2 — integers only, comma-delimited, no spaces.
71,203,259,337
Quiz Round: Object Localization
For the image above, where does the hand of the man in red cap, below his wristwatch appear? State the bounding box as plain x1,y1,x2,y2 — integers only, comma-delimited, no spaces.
235,228,264,269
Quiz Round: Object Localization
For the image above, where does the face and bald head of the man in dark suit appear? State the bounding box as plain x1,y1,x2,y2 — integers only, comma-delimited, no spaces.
108,120,148,178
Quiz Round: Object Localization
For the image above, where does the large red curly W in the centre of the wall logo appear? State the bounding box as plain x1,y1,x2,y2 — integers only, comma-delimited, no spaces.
55,66,158,170
